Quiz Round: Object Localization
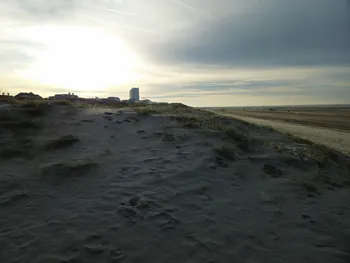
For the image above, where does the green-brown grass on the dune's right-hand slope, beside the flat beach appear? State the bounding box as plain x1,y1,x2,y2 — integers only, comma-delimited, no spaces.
134,104,350,180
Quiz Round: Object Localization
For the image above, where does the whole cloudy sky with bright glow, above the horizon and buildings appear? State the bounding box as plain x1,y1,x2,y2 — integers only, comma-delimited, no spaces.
0,0,350,106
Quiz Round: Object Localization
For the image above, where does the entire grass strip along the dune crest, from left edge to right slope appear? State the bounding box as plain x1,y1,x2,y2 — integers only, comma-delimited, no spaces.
0,100,346,167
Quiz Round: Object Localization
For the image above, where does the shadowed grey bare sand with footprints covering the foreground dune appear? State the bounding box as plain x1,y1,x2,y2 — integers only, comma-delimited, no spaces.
0,104,350,263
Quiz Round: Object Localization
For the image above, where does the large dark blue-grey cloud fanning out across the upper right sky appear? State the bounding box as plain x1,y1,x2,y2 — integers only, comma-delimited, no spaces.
143,0,350,67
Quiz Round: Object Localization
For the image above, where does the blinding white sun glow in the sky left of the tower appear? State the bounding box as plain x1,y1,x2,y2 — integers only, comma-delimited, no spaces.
18,26,141,90
